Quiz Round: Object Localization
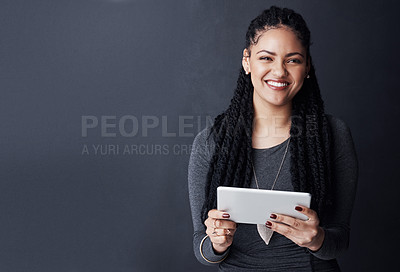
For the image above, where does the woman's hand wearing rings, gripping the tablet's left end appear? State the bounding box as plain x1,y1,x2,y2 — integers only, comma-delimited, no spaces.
204,209,236,253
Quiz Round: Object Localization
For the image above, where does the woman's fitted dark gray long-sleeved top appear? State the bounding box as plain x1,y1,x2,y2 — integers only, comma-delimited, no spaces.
188,114,358,271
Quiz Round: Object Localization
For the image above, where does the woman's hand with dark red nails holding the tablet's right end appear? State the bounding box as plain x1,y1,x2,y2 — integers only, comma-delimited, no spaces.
265,206,325,251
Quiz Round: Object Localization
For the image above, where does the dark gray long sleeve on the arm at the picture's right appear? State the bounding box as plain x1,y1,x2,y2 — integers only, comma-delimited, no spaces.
309,115,358,260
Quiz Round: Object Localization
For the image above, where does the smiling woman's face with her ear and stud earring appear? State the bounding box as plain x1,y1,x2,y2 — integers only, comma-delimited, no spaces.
243,28,309,106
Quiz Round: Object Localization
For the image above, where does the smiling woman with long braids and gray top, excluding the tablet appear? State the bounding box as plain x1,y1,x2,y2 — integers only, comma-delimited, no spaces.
188,6,358,271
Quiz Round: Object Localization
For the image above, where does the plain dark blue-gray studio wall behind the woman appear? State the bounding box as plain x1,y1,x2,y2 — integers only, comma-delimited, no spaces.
0,0,399,272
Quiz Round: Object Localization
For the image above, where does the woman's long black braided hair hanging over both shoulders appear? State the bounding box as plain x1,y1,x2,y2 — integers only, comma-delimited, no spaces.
202,6,332,224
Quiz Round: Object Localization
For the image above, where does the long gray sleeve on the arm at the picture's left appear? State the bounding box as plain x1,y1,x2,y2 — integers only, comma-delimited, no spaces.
188,128,229,265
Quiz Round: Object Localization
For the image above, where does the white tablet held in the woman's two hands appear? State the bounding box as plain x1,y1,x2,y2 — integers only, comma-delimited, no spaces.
217,186,311,224
